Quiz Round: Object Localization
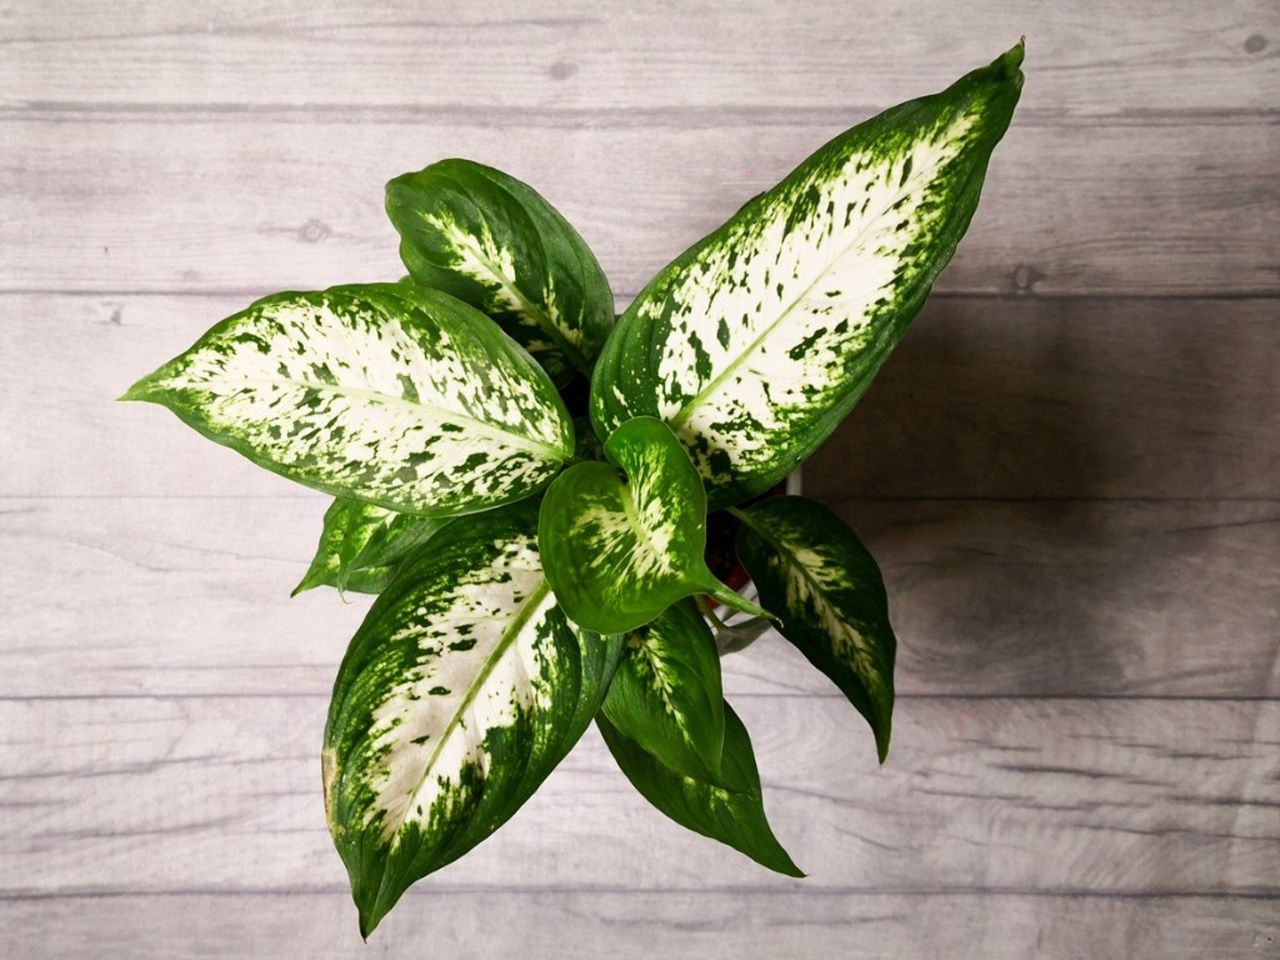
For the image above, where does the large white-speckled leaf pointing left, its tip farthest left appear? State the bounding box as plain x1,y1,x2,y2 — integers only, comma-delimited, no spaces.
123,284,573,516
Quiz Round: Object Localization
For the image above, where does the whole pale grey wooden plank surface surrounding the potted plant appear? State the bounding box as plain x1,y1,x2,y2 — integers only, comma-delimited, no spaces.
0,0,1280,959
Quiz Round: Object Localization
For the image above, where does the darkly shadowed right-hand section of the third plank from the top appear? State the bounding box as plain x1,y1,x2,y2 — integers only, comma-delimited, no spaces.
805,298,1280,500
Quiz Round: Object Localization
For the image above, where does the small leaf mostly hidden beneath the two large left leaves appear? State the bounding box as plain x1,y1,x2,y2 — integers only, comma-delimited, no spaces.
293,497,447,596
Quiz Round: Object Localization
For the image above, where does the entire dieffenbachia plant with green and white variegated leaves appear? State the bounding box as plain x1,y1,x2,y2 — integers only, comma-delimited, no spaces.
124,45,1023,936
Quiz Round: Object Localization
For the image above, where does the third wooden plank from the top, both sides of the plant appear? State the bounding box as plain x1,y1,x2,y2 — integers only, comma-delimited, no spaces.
0,294,1280,500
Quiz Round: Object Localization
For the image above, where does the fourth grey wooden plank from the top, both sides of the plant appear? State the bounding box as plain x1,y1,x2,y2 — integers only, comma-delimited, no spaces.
0,497,1280,698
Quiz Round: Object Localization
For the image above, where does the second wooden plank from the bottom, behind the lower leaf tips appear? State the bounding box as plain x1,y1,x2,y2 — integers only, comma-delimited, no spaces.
0,696,1280,896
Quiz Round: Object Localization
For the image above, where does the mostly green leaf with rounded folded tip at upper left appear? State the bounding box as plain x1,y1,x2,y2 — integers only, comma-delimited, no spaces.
387,160,614,384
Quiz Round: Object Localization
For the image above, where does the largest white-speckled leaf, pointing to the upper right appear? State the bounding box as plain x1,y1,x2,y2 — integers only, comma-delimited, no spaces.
591,45,1023,509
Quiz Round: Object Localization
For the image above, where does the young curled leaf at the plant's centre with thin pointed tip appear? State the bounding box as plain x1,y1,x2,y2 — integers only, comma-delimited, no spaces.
538,417,762,634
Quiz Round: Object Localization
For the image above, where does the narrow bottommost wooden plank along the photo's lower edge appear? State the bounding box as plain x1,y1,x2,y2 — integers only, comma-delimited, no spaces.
0,890,1280,960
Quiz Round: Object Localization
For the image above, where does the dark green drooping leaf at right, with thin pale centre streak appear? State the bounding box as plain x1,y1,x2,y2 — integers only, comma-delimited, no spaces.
735,497,897,763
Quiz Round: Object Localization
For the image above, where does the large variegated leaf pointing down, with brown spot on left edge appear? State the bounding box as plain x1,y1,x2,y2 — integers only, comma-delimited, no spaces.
324,502,621,936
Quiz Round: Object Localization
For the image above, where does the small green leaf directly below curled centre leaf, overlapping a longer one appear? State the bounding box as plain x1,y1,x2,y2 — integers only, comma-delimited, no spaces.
603,600,724,783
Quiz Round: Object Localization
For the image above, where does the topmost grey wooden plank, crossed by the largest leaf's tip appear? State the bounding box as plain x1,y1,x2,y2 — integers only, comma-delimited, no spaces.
0,0,1280,117
